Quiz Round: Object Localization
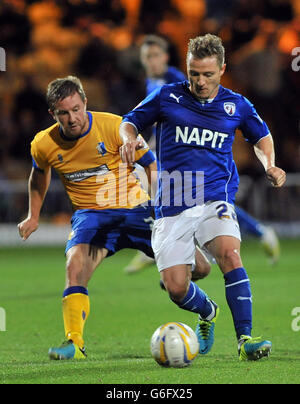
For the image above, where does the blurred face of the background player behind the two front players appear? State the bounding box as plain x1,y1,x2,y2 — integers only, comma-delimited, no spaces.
141,45,169,77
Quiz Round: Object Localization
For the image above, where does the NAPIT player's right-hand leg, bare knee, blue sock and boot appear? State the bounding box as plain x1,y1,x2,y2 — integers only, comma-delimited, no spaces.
206,236,272,360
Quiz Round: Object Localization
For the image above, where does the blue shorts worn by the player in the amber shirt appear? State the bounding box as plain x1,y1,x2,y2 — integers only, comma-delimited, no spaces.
65,205,154,258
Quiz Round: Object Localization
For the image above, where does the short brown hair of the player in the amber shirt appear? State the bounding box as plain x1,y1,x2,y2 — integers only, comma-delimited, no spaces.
46,76,86,111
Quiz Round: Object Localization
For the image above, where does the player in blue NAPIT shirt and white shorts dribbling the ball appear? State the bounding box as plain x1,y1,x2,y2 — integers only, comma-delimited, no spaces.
120,34,286,360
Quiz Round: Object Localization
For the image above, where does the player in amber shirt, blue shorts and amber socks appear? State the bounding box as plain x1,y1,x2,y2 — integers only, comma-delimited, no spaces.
18,76,156,359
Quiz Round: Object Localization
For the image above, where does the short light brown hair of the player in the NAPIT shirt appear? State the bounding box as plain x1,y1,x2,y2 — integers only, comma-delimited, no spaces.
187,34,225,68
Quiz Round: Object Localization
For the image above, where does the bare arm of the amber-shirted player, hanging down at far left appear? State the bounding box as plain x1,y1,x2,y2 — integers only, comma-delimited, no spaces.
18,167,51,240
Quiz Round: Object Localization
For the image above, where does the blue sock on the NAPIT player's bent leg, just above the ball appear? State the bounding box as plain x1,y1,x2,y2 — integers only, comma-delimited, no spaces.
173,282,215,320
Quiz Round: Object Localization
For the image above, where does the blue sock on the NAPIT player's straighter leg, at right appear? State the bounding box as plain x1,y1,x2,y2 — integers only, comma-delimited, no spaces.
224,268,252,339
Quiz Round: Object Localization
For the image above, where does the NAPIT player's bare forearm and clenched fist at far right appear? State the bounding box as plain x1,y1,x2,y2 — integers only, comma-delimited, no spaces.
254,135,286,187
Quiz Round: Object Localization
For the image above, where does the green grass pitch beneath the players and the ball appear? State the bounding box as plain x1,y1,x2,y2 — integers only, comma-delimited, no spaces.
0,240,300,384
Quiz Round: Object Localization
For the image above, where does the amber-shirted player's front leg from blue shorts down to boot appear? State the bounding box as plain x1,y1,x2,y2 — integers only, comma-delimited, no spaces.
49,209,123,359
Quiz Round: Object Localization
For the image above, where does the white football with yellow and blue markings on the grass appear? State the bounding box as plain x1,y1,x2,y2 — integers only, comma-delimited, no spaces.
150,322,199,368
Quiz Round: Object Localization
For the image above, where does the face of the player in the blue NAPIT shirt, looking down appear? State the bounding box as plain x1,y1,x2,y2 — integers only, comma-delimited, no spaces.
187,54,226,100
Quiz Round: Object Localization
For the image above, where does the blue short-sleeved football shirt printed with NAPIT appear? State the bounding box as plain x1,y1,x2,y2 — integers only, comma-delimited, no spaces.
123,81,270,218
